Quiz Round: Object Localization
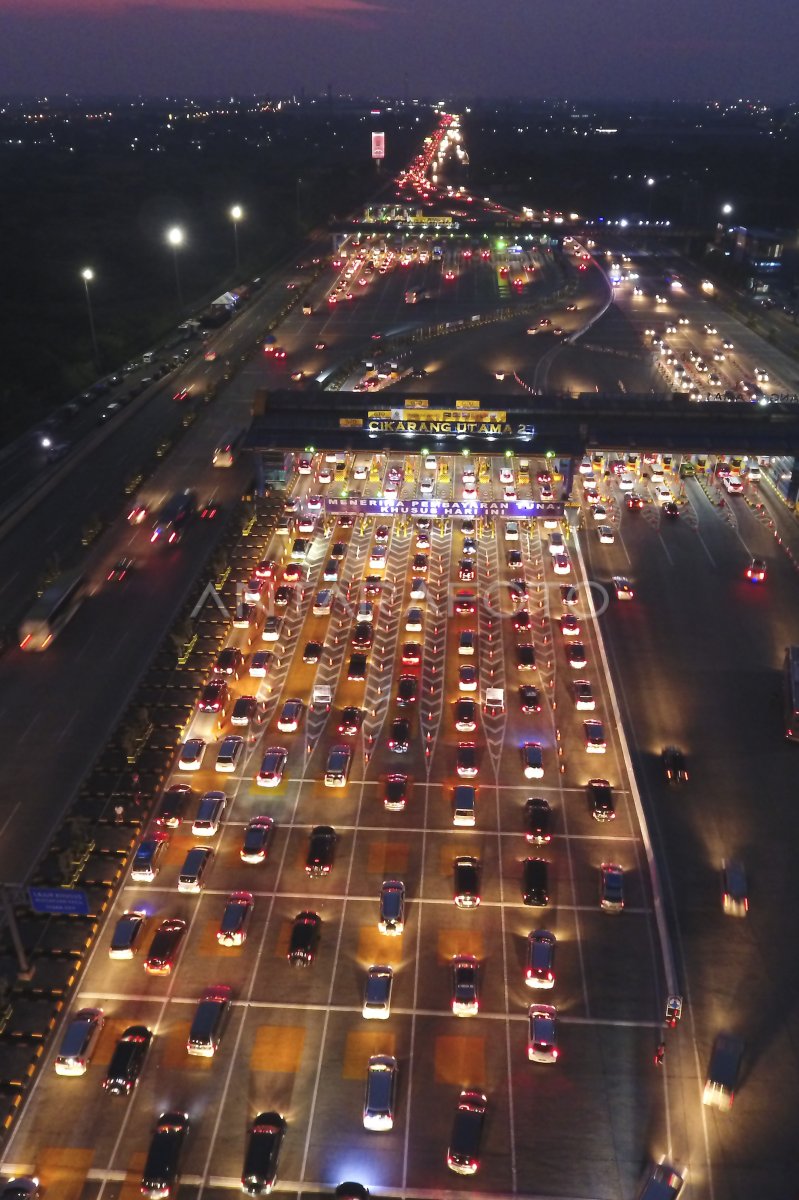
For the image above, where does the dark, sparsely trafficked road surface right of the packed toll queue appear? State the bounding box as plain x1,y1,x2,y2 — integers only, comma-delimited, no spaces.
585,460,798,1198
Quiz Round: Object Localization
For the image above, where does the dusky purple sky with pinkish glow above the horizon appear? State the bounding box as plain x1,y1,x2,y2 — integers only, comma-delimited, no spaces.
0,0,799,103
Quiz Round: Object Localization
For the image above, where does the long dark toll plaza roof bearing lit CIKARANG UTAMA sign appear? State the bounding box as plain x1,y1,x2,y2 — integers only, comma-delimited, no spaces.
245,388,799,463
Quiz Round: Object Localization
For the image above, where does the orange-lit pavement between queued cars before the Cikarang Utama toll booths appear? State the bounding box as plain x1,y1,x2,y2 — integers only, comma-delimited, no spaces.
5,455,665,1198
